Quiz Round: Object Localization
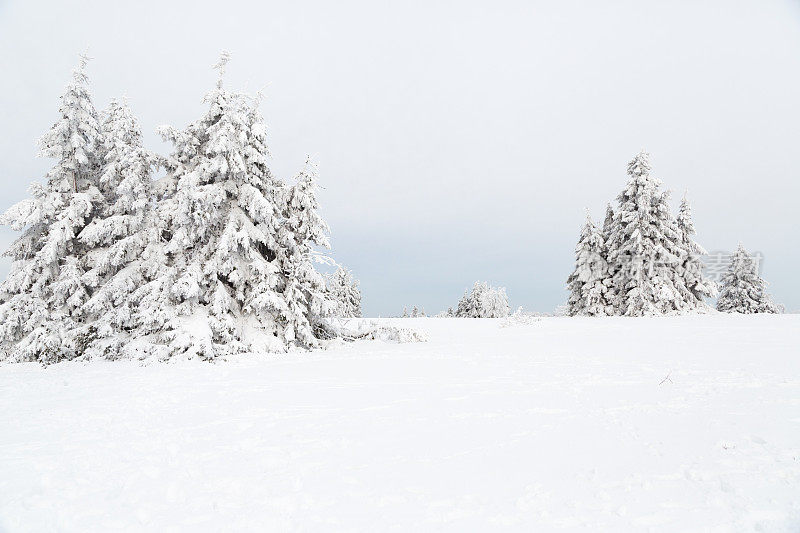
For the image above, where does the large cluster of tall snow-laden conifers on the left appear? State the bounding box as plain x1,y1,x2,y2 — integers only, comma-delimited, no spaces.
0,54,360,363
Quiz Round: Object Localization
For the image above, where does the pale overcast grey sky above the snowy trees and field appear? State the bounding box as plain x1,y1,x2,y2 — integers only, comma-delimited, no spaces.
0,0,800,315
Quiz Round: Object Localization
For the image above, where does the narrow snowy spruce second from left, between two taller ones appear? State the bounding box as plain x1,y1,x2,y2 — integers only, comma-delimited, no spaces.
78,100,156,357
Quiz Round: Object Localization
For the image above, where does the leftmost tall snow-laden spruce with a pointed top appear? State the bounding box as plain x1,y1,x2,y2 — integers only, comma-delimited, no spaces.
0,57,103,363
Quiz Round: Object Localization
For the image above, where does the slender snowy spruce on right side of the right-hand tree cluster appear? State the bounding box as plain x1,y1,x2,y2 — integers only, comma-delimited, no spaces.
677,195,717,310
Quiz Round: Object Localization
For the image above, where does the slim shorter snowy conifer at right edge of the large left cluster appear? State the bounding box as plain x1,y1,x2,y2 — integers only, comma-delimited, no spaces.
278,159,336,348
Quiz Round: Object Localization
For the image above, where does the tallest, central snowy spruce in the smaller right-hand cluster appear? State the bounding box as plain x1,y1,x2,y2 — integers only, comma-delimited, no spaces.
606,151,686,316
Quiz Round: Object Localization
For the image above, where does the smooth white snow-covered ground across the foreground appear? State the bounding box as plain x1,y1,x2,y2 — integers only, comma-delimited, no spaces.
0,315,800,531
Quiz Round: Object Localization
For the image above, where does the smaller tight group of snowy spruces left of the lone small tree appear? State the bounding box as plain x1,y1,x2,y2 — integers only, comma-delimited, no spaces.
567,151,717,316
